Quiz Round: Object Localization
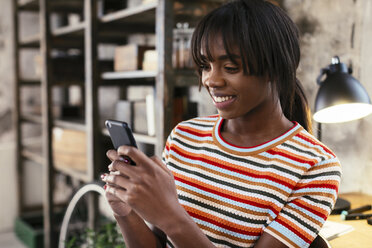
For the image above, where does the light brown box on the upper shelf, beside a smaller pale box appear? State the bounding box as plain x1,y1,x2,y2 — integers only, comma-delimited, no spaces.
114,44,155,71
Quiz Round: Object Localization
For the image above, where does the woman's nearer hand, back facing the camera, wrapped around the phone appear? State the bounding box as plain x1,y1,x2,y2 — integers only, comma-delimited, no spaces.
103,146,185,231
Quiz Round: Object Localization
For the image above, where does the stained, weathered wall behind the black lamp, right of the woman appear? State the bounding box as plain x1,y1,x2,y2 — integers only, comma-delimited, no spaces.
283,0,372,194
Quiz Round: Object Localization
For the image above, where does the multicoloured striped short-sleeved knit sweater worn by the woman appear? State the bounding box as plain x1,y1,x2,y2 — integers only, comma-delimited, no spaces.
163,115,341,247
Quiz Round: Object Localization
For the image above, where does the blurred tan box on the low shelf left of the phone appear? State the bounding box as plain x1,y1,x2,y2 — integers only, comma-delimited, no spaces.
52,128,87,171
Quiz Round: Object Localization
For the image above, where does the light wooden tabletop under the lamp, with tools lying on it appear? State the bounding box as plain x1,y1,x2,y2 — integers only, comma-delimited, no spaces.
328,193,372,248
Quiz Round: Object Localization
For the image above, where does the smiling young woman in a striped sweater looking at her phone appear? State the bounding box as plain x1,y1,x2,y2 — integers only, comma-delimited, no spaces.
103,0,341,248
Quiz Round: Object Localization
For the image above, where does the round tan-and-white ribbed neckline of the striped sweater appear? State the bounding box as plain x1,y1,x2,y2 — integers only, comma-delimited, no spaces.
212,116,303,156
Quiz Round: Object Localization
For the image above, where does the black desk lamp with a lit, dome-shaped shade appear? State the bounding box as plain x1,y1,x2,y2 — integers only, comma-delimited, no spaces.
313,56,372,214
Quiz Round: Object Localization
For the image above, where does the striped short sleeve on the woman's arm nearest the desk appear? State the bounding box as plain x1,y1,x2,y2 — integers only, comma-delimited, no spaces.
264,157,341,247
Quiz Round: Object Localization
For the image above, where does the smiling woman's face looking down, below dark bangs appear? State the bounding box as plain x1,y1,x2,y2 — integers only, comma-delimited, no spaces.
202,39,277,119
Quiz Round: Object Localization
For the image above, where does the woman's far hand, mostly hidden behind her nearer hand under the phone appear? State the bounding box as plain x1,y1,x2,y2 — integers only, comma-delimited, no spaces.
101,150,132,217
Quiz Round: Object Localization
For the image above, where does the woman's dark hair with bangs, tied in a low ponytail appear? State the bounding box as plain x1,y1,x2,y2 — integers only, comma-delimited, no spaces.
191,0,311,131
